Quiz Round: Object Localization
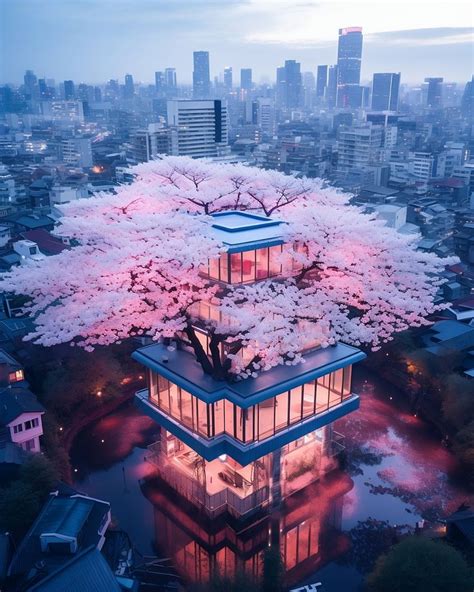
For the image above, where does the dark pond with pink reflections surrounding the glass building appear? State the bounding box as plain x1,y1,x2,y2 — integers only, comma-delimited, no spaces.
71,367,474,592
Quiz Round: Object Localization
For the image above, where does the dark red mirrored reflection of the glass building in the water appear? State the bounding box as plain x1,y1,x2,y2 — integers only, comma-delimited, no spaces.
142,471,353,586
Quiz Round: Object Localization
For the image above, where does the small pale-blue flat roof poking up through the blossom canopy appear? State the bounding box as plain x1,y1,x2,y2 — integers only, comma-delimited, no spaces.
212,210,285,253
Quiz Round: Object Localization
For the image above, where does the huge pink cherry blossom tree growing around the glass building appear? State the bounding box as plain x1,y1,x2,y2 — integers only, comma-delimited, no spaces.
0,157,453,379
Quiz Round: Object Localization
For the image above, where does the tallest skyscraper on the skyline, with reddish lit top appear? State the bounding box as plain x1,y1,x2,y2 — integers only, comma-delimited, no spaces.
337,27,363,108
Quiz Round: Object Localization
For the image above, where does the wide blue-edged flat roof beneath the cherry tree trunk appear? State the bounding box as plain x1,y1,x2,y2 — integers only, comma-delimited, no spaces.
132,343,366,408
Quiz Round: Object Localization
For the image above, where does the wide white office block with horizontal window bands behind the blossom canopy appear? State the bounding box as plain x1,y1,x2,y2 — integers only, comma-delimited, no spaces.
167,100,228,158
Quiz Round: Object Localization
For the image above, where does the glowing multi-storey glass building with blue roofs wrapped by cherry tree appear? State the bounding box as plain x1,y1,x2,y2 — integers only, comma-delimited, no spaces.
133,211,365,519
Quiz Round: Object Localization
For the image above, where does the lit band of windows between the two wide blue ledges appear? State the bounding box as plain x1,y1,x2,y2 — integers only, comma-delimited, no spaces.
149,366,352,443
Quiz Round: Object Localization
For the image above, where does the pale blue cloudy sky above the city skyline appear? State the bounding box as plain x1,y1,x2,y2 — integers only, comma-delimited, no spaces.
0,0,474,84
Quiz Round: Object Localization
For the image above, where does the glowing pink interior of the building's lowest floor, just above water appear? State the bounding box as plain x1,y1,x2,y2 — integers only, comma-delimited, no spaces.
146,428,335,515
